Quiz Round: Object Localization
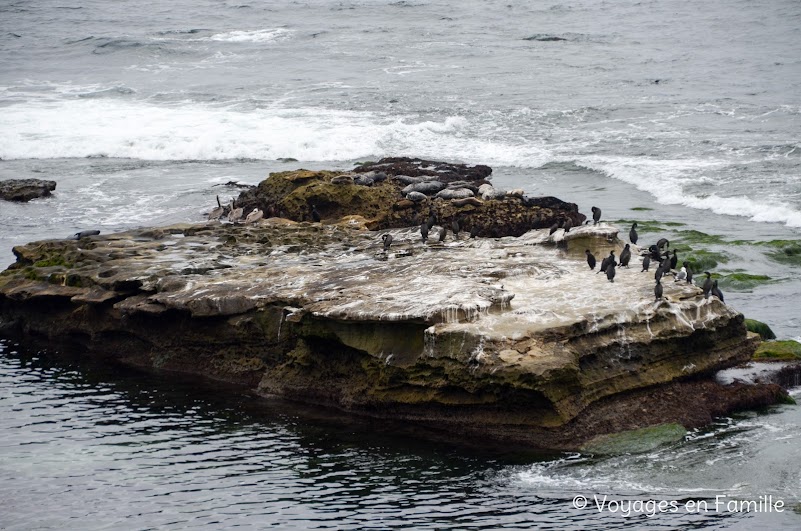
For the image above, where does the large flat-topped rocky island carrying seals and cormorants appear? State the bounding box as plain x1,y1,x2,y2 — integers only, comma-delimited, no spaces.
0,159,787,449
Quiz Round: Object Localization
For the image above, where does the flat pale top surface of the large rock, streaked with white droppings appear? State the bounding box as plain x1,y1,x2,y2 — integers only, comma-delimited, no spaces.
0,219,736,340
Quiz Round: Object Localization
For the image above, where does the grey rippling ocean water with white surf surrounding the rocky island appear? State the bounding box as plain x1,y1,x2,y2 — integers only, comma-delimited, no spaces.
0,0,801,529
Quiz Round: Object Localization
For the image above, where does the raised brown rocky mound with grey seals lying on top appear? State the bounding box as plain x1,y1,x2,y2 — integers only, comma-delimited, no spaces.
231,158,586,238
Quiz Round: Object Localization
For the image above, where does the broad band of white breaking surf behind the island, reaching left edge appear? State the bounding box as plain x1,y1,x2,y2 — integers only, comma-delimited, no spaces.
0,99,548,166
